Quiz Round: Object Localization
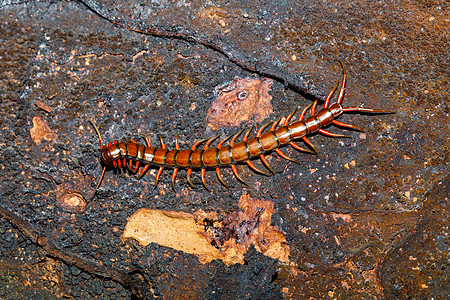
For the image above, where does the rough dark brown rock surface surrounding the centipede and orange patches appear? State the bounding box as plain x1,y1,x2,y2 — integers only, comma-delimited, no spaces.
0,0,450,299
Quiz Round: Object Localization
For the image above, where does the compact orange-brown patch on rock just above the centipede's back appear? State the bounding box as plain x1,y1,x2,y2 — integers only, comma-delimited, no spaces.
206,77,273,130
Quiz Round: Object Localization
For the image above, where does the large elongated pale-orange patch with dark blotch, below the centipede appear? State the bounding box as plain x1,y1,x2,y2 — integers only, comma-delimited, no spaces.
122,195,290,265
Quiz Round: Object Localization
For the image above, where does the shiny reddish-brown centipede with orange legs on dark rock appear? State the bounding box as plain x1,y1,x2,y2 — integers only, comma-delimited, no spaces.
91,61,394,197
